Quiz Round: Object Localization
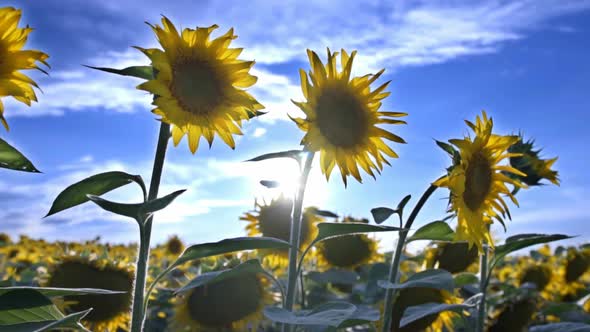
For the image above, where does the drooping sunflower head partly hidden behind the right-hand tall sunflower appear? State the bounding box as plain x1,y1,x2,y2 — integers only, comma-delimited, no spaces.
506,135,559,186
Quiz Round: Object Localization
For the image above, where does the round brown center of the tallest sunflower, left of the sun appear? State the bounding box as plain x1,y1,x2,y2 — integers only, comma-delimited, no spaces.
171,59,226,115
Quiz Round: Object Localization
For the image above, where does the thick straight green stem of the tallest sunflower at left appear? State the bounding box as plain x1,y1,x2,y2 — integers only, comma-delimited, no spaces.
131,122,170,332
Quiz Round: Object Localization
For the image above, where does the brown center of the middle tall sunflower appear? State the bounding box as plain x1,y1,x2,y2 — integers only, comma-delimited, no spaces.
316,85,369,148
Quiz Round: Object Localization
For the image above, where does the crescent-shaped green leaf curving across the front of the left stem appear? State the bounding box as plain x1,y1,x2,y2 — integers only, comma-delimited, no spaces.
88,189,186,220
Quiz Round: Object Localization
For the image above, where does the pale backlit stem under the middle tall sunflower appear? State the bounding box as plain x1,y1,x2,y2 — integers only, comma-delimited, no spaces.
283,151,315,332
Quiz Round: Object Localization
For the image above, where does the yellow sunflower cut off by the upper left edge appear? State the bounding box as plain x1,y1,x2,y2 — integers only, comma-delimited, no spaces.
0,7,49,130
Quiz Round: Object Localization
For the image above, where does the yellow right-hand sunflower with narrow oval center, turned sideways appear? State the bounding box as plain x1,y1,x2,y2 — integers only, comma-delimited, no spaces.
434,112,526,251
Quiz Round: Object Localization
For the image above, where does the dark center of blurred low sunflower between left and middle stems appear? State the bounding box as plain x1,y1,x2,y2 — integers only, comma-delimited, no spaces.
187,274,263,328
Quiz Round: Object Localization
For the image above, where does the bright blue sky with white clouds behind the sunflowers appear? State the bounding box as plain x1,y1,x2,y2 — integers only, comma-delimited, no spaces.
0,0,590,249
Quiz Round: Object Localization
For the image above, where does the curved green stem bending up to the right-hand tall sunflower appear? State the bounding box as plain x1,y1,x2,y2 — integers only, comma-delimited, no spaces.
382,184,438,332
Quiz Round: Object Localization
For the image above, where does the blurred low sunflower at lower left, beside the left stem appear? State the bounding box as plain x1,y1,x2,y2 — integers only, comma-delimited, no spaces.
43,256,134,331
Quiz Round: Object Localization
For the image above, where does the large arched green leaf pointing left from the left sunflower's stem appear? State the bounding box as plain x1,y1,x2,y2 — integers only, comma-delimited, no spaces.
45,171,146,217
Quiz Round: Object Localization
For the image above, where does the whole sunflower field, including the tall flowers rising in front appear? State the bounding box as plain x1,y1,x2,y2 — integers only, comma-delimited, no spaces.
0,7,590,332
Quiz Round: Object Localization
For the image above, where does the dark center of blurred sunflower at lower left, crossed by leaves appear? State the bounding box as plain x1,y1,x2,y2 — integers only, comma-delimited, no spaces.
48,262,133,322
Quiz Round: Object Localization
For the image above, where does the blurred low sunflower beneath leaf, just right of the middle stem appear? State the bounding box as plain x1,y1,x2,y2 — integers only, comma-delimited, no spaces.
316,217,383,270
